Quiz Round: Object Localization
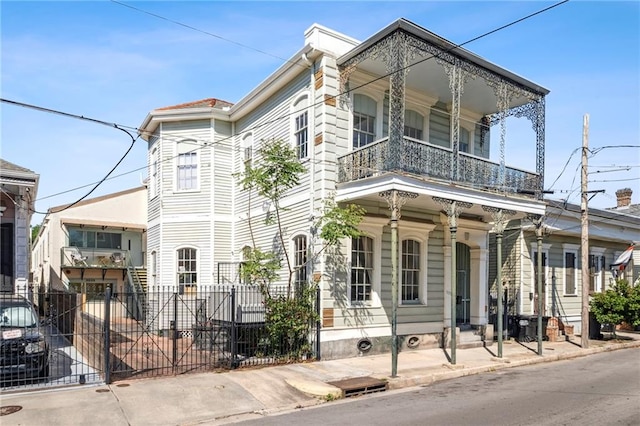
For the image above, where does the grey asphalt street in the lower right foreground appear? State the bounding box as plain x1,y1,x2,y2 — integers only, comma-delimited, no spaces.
236,349,640,426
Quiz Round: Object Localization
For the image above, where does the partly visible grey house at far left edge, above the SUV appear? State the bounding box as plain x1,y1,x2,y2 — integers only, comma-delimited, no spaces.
0,159,39,296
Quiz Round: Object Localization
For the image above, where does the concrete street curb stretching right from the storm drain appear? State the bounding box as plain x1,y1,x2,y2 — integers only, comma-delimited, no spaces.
385,341,640,390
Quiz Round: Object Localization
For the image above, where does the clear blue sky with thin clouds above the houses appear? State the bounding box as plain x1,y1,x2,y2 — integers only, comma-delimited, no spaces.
0,1,640,224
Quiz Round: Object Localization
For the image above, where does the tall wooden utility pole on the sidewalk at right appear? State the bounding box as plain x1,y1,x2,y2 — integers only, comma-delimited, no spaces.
580,114,590,349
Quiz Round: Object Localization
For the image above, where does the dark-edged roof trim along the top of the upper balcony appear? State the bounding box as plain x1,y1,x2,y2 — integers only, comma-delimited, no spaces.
337,18,549,96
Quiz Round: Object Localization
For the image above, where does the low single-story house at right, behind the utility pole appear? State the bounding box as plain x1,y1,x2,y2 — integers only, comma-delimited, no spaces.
496,200,640,332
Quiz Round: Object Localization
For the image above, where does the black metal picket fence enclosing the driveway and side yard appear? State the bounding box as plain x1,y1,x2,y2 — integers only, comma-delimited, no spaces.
2,285,320,391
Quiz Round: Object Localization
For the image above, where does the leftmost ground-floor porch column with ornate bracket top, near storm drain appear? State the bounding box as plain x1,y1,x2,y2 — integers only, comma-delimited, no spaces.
379,189,418,377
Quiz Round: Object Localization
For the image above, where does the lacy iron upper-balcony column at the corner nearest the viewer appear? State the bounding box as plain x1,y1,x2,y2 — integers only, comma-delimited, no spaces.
384,32,410,171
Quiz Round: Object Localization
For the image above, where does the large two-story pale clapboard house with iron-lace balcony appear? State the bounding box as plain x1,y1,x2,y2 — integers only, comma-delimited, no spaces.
140,19,549,358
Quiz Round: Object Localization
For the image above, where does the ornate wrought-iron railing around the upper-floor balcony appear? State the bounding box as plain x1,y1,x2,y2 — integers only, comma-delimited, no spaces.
338,137,541,193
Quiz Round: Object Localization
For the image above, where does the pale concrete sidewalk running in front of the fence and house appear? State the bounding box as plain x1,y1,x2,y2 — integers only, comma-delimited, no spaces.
0,332,640,426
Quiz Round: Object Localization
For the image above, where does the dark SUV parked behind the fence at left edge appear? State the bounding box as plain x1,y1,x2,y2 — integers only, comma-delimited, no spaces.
0,294,49,381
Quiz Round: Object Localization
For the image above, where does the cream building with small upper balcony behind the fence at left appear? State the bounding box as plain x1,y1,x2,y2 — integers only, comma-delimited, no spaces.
31,186,147,306
